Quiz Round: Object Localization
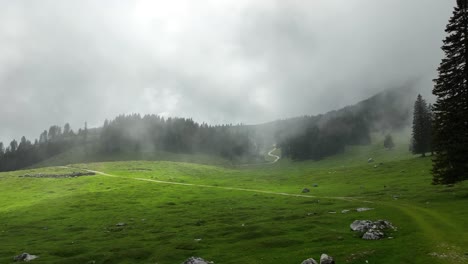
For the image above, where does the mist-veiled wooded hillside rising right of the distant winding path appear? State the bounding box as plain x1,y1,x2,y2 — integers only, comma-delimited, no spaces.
275,85,414,160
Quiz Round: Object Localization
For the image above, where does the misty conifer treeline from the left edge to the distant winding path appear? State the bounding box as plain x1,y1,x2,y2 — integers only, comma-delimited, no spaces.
0,114,258,171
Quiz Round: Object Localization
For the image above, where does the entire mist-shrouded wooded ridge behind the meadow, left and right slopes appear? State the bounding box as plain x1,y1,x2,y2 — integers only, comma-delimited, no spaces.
0,87,414,171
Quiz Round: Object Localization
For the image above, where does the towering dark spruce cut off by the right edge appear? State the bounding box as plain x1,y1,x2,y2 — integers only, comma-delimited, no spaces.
432,0,468,184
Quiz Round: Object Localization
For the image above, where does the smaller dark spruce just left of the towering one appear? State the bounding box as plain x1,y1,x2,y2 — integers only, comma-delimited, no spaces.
412,94,431,157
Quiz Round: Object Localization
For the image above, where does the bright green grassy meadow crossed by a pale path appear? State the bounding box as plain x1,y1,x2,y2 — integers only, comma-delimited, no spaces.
0,139,468,264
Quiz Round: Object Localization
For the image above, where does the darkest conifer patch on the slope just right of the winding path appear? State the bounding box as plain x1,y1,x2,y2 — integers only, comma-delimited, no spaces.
276,112,370,160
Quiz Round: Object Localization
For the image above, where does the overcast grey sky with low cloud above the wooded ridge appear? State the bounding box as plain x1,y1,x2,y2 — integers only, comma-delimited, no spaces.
0,0,455,144
